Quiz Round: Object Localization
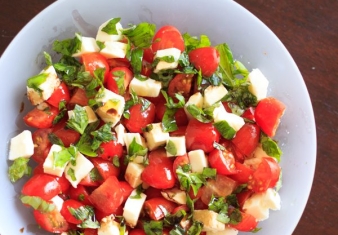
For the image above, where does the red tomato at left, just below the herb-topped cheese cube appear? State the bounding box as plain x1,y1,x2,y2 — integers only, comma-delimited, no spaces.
23,103,59,128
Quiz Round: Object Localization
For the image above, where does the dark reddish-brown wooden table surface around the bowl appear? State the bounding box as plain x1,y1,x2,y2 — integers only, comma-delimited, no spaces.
0,0,338,235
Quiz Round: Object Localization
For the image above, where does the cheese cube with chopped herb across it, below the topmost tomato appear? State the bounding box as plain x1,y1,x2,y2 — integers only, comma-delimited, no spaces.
154,48,181,73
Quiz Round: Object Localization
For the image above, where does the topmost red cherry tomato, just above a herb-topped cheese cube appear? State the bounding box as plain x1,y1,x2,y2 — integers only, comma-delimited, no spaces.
152,25,185,53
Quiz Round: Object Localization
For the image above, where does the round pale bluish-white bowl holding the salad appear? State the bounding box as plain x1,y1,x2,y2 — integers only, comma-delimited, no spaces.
0,0,316,235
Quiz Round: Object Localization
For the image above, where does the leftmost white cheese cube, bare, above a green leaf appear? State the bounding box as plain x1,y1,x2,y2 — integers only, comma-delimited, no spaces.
8,130,34,161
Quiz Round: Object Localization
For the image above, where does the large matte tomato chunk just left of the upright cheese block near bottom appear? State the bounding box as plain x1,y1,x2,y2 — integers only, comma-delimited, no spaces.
89,176,123,214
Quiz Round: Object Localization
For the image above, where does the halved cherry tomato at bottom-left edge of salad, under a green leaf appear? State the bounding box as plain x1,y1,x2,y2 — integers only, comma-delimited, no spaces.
33,209,69,233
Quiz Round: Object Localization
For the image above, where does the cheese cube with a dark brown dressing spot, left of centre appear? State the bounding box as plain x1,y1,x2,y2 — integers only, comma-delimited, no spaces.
96,88,125,127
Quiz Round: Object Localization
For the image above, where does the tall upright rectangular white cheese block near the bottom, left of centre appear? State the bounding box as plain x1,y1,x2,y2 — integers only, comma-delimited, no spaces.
123,190,147,228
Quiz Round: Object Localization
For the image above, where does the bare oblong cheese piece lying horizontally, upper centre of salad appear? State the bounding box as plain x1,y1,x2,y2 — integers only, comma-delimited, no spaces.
129,78,162,97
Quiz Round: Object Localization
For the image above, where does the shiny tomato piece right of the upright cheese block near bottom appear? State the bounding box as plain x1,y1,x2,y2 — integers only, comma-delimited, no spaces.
144,197,177,220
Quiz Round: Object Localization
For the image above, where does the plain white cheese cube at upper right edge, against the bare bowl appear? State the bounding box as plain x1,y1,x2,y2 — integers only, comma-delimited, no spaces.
248,69,269,101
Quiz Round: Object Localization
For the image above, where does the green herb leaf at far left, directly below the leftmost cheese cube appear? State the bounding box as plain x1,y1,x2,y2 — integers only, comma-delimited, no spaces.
8,157,32,183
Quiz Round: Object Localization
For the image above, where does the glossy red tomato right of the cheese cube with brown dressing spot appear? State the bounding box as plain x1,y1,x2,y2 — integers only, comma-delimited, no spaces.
122,103,155,133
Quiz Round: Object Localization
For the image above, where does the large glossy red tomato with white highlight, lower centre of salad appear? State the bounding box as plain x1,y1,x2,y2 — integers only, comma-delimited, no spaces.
141,149,175,189
